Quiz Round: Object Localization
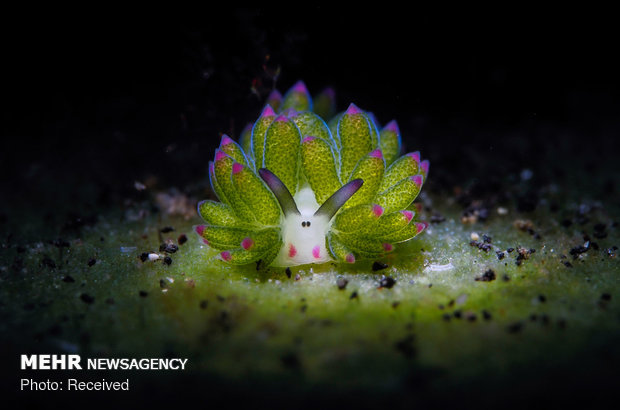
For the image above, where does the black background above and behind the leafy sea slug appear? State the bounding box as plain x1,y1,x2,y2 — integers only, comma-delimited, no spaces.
0,10,620,221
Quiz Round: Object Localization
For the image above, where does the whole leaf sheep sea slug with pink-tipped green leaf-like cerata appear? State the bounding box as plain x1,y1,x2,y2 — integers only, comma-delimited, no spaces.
194,81,429,267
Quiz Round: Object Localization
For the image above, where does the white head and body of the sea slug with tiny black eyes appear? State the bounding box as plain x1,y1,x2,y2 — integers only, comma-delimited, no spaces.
273,185,332,267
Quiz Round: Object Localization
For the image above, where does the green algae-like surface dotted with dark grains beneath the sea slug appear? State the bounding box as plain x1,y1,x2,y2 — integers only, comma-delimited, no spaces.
0,183,620,402
